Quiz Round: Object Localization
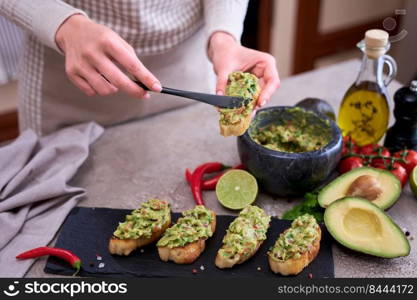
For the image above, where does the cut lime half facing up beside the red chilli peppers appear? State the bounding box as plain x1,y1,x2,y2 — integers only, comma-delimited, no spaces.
216,170,258,209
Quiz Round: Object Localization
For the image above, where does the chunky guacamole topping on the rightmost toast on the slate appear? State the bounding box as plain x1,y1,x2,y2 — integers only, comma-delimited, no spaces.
269,214,320,261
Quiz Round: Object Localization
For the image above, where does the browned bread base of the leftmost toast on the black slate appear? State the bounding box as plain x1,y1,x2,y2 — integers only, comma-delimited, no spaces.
109,218,171,255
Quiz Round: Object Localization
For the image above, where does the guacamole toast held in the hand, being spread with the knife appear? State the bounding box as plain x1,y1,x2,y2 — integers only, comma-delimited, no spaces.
219,71,261,137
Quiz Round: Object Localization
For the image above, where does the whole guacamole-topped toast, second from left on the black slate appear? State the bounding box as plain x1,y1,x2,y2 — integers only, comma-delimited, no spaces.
156,205,216,264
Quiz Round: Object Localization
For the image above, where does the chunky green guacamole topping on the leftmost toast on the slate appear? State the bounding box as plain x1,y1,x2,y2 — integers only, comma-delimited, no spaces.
113,199,171,239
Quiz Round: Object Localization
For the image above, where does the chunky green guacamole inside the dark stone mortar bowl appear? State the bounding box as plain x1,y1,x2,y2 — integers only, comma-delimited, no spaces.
251,107,332,153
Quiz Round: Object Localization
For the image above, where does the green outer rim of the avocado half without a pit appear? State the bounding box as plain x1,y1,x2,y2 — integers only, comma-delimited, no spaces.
324,197,411,258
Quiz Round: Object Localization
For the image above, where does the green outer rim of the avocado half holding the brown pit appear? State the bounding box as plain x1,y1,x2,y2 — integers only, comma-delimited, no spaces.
318,167,402,210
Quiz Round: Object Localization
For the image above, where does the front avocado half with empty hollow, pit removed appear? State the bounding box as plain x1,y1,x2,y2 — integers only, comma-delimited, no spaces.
324,197,410,258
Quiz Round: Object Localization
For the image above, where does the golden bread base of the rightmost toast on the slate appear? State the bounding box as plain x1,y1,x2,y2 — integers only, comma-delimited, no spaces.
268,214,321,276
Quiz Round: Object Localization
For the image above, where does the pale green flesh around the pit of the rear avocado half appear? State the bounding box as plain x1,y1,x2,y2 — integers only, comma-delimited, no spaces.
318,167,401,210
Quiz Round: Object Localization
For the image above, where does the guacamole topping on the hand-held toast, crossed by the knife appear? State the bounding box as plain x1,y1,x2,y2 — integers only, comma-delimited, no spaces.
219,71,259,125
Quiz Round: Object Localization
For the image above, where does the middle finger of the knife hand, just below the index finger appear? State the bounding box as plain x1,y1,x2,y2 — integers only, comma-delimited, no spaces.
95,55,150,98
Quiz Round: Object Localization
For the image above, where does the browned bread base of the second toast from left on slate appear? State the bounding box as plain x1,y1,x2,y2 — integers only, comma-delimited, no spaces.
158,211,216,264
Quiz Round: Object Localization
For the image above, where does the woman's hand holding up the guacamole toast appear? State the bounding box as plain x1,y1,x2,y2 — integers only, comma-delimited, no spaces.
208,32,280,107
